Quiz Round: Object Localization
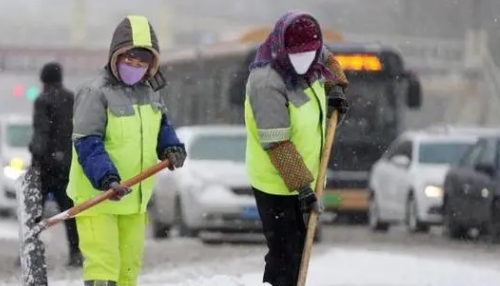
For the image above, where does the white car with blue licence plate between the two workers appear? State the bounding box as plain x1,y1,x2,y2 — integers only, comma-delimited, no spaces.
149,125,321,242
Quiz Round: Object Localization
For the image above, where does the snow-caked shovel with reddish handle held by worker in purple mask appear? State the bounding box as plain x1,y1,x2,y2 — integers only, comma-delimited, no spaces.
18,160,170,286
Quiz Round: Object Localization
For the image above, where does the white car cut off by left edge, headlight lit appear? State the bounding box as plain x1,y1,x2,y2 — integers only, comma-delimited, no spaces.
0,114,33,215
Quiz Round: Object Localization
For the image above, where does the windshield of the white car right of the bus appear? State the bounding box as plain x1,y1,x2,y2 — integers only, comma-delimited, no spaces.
418,142,472,164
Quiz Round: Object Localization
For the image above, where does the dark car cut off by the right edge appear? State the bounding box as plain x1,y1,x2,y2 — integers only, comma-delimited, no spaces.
443,135,500,241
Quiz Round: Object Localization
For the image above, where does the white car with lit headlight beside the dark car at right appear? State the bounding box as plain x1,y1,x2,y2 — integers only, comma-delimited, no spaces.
368,127,499,232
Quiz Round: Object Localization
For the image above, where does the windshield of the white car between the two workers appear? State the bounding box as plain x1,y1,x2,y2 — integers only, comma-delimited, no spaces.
189,134,247,162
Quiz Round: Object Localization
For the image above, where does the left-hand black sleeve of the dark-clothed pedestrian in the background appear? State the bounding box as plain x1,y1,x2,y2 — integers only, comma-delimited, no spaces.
29,96,51,160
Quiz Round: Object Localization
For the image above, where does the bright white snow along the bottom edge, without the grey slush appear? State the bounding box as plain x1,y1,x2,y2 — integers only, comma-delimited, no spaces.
42,248,500,286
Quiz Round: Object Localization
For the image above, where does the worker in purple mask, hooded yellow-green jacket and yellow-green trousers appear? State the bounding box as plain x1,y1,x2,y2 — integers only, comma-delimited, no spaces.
67,15,186,286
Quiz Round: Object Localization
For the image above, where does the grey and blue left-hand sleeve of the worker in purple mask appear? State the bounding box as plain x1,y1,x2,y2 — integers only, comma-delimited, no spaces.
73,88,120,190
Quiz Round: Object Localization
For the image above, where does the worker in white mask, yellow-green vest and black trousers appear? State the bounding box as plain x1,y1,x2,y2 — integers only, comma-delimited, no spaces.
245,12,348,286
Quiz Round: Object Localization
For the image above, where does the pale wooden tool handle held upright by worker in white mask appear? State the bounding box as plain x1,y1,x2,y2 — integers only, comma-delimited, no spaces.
297,111,338,286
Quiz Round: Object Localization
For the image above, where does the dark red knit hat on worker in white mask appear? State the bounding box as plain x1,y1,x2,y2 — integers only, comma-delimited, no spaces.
285,17,321,54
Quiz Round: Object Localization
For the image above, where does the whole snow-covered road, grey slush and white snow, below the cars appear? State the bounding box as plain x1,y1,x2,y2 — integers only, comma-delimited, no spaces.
0,220,500,286
